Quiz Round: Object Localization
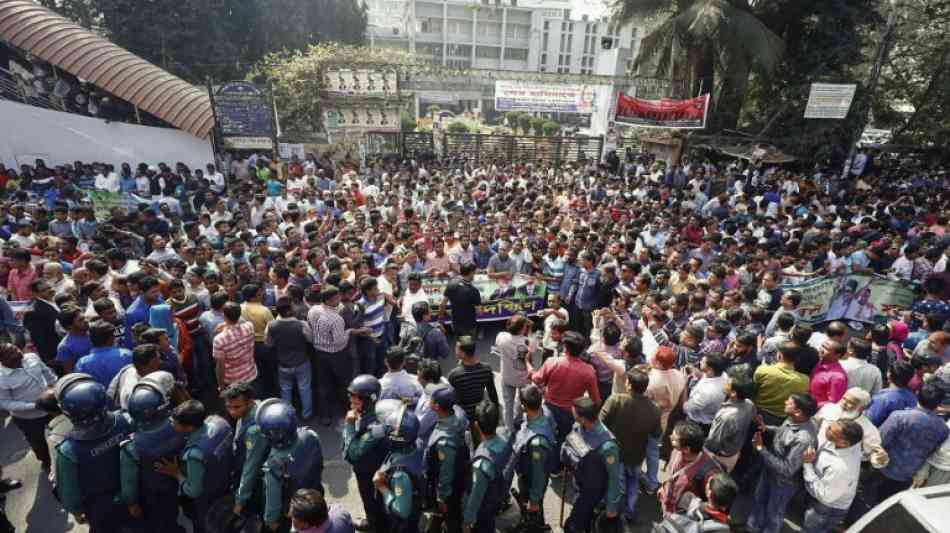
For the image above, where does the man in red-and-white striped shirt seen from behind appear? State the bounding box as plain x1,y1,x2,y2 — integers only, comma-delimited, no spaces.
211,302,259,392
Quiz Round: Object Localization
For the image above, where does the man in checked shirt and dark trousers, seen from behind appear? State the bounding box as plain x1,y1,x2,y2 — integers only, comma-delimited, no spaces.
307,285,372,426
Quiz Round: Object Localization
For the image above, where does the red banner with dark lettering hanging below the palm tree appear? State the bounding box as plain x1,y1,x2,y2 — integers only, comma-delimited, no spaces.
615,93,709,130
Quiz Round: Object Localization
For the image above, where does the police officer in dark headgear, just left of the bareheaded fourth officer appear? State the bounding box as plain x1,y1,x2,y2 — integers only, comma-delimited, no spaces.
423,385,470,533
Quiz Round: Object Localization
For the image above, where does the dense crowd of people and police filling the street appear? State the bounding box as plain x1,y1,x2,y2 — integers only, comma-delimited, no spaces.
0,151,950,533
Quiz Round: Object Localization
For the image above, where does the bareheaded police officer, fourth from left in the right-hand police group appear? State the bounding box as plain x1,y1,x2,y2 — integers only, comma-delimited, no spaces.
462,399,511,533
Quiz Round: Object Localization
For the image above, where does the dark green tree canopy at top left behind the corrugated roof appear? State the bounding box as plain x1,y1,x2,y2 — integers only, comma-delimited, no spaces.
39,0,367,83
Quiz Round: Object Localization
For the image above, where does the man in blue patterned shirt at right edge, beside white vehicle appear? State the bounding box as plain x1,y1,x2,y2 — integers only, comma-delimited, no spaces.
871,382,950,505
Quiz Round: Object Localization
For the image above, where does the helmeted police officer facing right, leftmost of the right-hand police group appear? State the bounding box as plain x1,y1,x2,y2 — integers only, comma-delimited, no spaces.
343,374,389,532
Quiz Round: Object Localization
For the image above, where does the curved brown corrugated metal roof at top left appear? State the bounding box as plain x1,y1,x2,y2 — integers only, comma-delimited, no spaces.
0,0,214,139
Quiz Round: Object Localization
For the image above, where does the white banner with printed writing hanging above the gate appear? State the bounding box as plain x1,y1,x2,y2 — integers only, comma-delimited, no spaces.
495,80,602,115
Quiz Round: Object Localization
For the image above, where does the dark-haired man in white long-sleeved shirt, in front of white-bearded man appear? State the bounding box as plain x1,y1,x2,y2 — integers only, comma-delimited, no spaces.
802,420,864,533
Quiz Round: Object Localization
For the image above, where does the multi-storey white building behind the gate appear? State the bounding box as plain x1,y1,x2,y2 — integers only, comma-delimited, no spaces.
367,0,643,74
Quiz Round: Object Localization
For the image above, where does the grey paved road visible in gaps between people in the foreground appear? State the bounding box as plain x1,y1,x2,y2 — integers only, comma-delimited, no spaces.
0,324,799,533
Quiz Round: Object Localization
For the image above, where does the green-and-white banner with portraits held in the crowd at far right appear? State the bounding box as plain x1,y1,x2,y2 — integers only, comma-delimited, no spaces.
782,274,914,323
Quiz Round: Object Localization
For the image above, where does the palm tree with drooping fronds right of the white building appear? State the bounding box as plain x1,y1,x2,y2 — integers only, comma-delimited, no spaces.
613,0,784,128
